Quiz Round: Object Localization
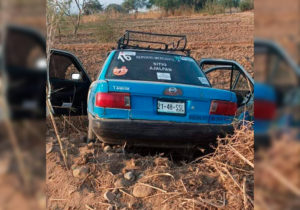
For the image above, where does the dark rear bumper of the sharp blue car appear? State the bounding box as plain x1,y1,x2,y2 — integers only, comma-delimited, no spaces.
90,116,234,148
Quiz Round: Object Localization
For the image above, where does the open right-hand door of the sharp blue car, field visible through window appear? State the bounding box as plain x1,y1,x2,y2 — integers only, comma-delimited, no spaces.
199,59,254,107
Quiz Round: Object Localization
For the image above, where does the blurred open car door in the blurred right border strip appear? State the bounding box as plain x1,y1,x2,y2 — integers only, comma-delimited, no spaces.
254,39,300,107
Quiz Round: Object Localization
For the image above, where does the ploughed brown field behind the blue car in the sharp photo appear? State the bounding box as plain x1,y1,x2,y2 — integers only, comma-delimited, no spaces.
54,12,254,79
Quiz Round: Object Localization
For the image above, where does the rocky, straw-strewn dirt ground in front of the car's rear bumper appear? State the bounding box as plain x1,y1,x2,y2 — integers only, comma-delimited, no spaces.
46,119,254,210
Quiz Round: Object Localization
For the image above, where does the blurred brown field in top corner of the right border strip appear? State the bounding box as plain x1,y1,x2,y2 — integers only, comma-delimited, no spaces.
254,0,300,63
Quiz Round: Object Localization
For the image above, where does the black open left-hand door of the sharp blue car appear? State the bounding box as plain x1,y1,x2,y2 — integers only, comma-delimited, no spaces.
48,50,91,116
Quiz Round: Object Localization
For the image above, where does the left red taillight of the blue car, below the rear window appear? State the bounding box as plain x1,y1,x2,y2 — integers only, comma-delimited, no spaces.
95,93,131,109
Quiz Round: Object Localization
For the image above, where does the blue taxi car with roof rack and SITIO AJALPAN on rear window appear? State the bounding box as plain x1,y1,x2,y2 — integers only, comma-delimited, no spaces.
50,31,253,148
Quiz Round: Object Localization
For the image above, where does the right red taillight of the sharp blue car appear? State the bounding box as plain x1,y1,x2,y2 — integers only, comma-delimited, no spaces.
209,100,237,116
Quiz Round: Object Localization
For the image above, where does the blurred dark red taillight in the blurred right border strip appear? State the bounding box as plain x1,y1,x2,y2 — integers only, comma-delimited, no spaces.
254,100,276,120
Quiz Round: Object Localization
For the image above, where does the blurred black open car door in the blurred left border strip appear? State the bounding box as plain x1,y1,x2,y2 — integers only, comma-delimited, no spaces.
0,25,47,120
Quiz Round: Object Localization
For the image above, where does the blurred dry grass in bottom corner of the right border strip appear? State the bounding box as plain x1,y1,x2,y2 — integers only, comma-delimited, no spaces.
255,136,300,210
